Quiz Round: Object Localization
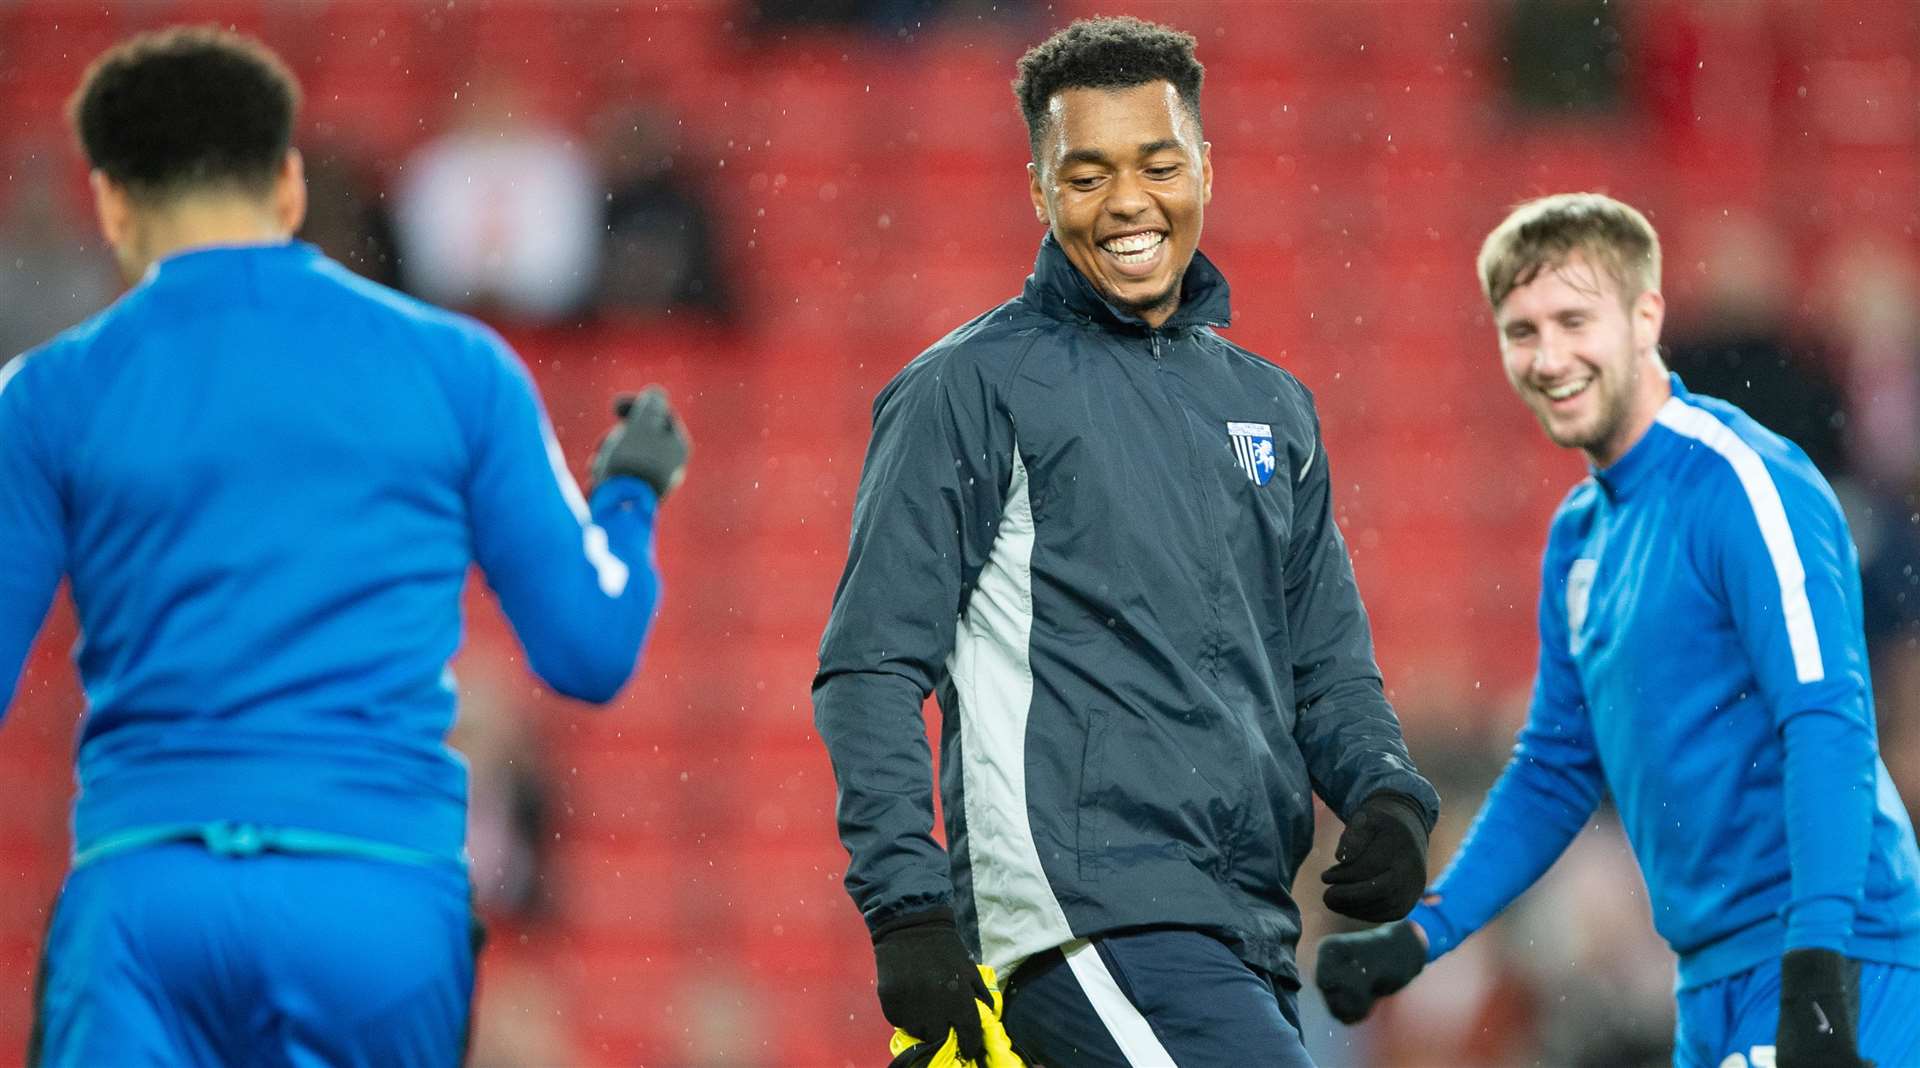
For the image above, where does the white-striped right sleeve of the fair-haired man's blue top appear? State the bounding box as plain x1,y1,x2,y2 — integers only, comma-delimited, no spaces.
1705,448,1878,951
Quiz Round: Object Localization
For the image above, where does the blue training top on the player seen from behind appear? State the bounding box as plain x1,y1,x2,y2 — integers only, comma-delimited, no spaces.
0,242,659,861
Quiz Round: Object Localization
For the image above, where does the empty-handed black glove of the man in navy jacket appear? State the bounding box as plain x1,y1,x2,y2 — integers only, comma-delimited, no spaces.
1321,789,1427,924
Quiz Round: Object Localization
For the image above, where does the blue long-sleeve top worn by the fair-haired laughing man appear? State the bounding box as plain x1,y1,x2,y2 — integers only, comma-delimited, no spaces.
1413,376,1920,987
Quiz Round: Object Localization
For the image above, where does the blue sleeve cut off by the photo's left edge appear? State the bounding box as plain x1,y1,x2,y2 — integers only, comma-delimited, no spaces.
0,355,67,718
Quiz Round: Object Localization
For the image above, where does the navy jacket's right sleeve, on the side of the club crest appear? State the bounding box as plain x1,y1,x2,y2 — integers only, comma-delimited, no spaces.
1286,399,1440,830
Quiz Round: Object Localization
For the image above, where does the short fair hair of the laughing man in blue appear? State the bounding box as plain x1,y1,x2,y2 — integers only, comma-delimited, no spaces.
1478,192,1661,309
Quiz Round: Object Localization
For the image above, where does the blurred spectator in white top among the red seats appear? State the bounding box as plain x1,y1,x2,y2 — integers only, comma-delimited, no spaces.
394,69,607,323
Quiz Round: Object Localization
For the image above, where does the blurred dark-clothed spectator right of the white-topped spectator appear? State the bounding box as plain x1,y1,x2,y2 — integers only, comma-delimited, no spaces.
593,106,733,319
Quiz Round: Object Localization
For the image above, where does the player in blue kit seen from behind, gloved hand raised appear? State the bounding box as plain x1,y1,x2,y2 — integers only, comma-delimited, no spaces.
0,29,687,1066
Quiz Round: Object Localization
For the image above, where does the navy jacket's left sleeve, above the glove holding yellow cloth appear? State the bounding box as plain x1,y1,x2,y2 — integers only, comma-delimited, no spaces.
814,359,1014,926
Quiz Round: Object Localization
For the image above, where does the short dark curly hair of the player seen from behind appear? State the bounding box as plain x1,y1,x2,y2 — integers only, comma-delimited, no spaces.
67,27,300,200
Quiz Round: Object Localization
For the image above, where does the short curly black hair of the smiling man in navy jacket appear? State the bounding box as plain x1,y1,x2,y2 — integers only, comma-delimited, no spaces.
1014,15,1206,159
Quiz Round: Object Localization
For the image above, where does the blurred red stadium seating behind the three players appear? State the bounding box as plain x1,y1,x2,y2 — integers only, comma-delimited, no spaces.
0,0,1920,1064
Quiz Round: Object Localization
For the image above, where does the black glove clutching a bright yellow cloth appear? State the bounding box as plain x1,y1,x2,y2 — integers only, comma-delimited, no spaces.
874,907,993,1060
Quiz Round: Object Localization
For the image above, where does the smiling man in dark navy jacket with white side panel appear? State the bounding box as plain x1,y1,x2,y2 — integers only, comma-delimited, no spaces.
814,19,1438,1066
